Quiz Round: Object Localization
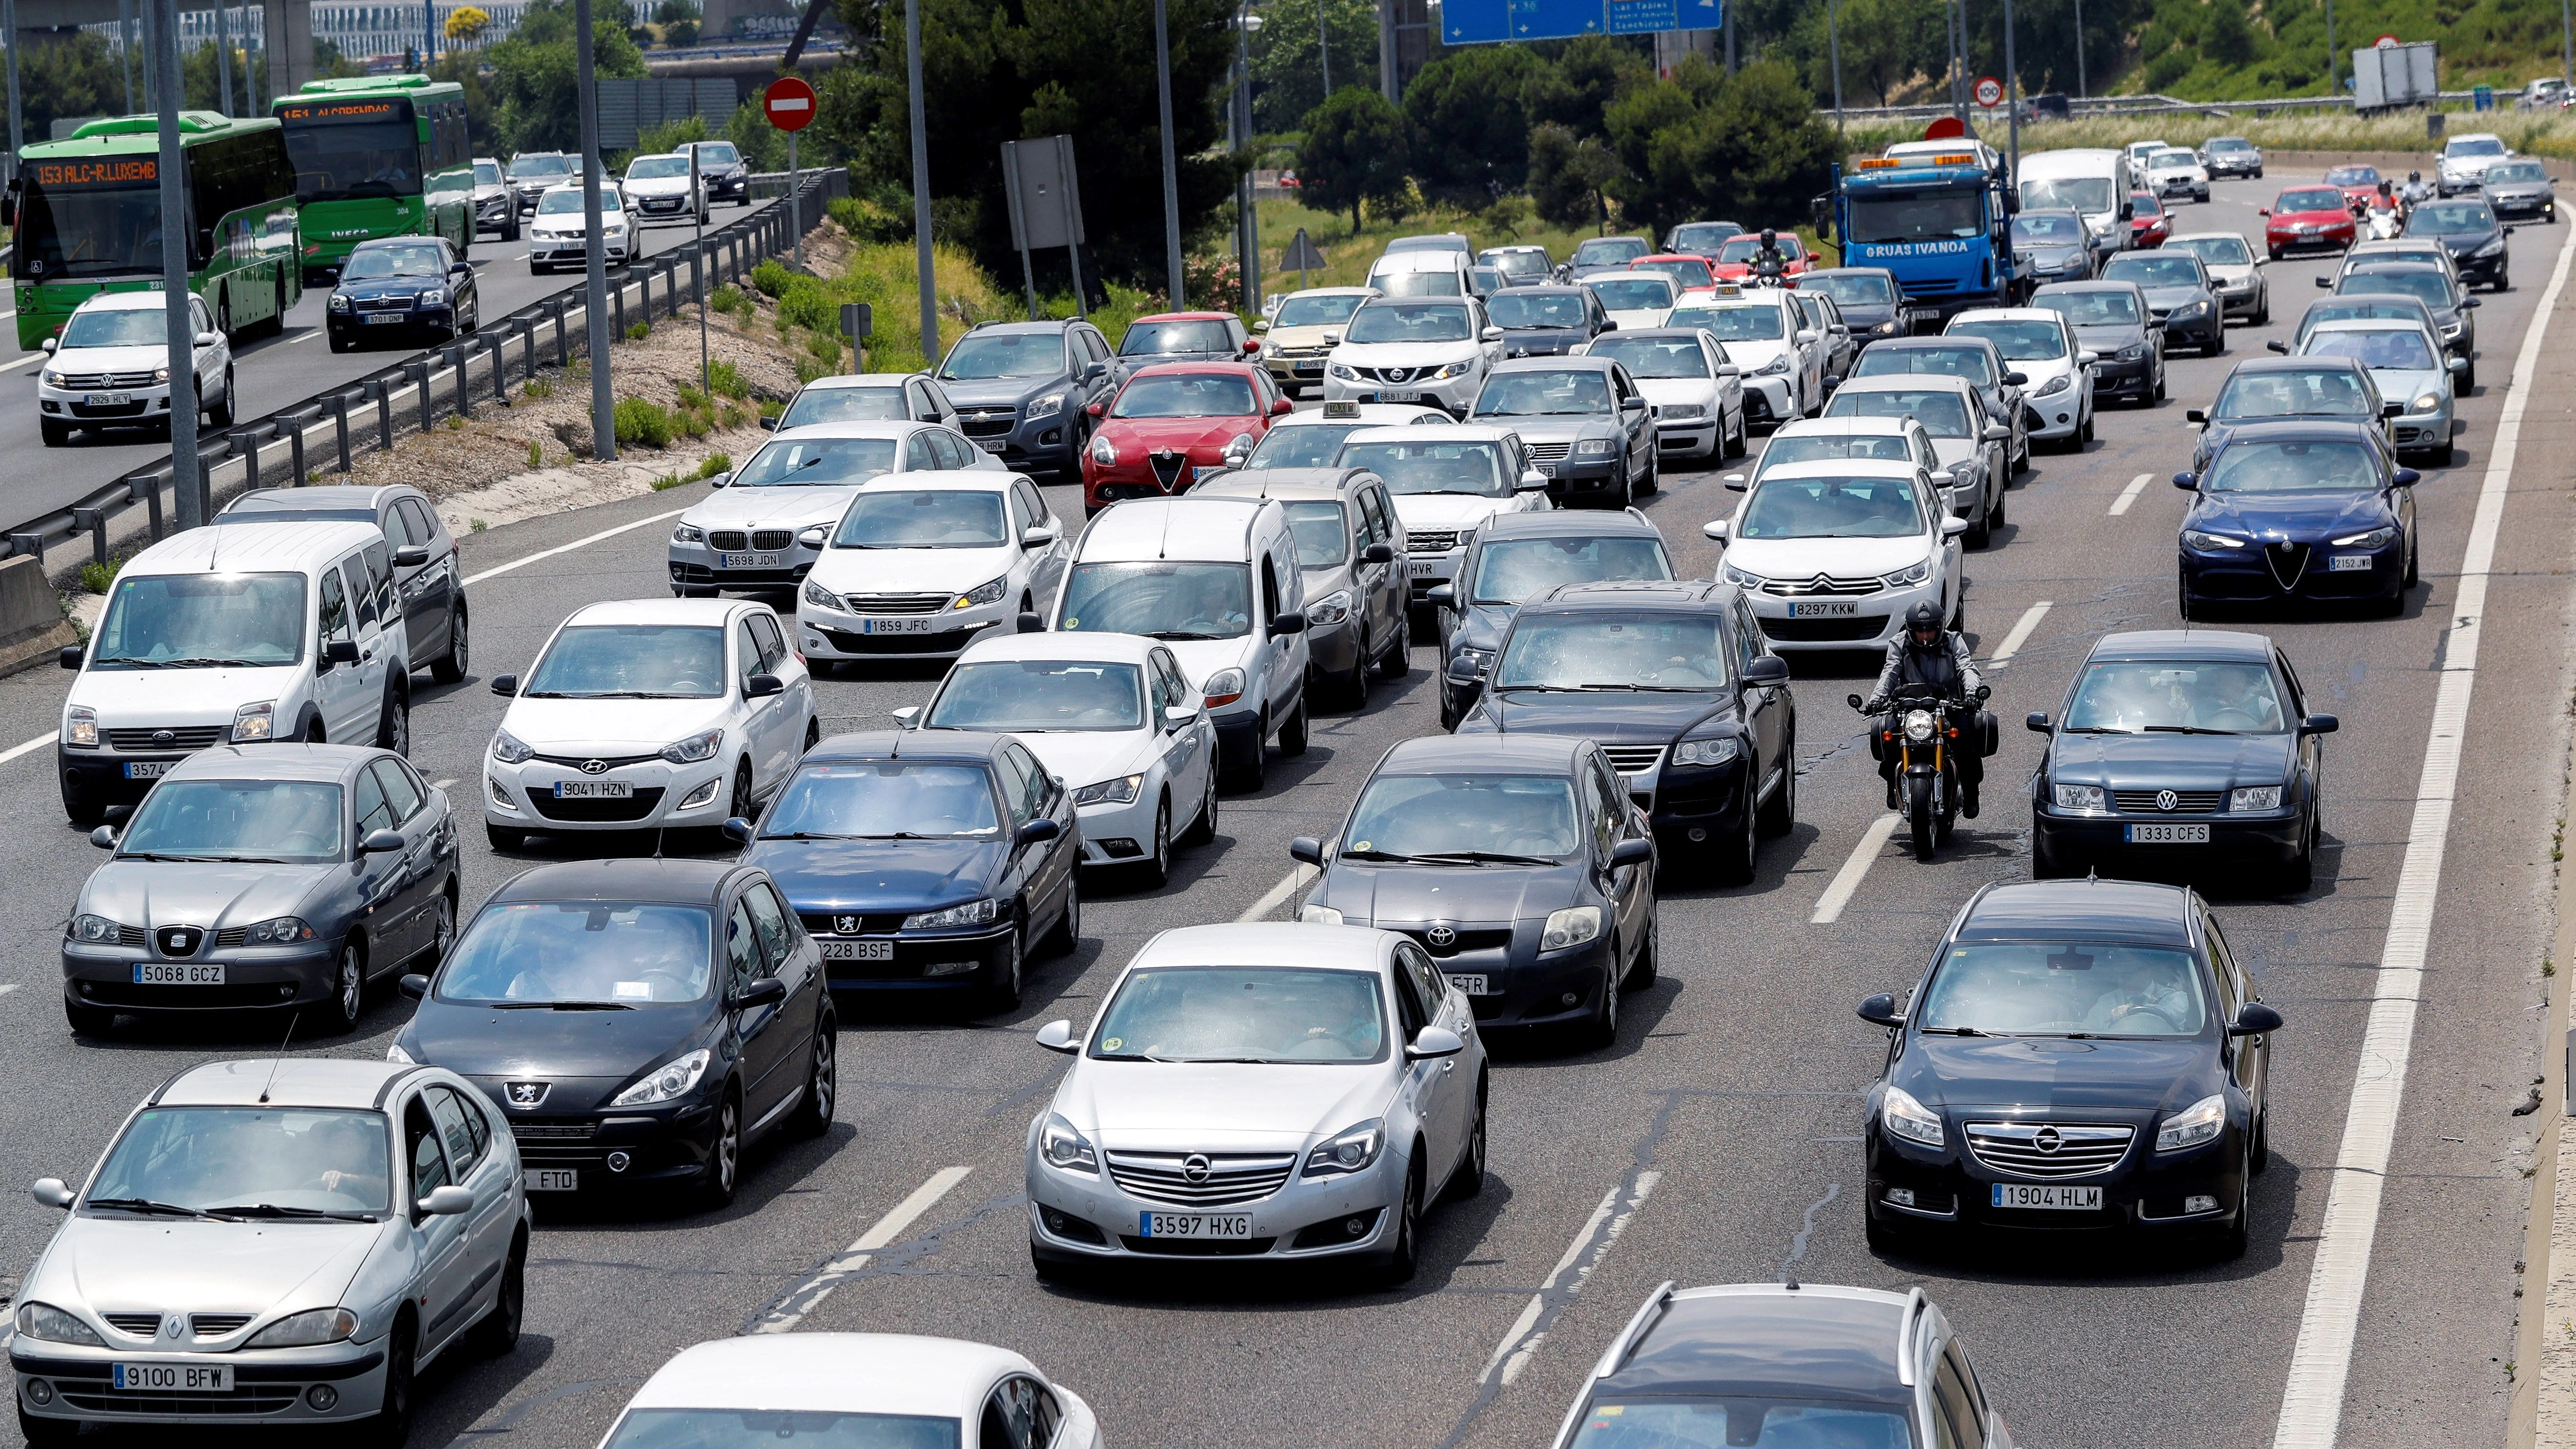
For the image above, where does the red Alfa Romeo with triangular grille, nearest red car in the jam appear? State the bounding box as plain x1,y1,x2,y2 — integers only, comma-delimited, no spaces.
1082,363,1296,515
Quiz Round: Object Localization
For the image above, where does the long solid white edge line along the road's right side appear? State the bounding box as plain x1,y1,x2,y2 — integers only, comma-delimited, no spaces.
2272,210,2576,1449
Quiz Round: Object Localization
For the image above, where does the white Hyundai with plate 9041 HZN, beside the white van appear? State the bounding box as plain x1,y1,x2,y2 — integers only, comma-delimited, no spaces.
484,600,817,849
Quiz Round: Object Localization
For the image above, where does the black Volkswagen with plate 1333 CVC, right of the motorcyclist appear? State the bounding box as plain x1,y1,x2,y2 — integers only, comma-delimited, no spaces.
2025,628,2337,890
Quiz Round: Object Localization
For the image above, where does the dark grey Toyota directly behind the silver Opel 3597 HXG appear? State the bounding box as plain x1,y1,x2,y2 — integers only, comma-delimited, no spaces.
1288,733,1656,1045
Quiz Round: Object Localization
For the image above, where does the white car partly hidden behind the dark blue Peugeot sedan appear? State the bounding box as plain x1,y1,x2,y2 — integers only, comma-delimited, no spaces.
894,633,1216,888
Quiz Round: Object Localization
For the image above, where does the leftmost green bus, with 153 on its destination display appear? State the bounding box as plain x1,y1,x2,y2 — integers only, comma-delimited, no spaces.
5,111,304,350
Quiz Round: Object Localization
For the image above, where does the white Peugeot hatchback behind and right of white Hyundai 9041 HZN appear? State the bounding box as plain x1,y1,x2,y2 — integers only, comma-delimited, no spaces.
796,469,1074,672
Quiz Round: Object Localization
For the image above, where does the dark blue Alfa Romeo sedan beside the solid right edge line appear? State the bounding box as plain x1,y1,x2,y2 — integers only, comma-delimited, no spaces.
2174,422,2421,618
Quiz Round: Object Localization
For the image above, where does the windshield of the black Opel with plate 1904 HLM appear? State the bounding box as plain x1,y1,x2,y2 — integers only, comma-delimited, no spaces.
1914,942,2210,1037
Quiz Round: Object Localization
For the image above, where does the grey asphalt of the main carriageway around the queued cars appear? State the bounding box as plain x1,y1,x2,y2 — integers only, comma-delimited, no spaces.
0,175,2576,1449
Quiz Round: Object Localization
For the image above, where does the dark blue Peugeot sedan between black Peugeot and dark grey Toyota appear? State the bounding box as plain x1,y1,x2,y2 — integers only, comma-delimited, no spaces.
745,728,1082,1012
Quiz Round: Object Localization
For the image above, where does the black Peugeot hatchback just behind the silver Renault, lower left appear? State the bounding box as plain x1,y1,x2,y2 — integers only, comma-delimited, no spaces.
386,860,840,1207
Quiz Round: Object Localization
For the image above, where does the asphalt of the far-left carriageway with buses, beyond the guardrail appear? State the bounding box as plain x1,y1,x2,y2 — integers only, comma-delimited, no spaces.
0,201,773,525
